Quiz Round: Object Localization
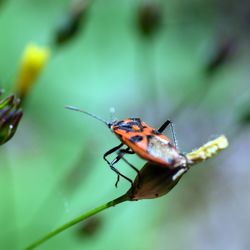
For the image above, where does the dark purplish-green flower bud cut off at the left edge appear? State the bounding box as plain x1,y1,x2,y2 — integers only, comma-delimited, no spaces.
0,92,22,145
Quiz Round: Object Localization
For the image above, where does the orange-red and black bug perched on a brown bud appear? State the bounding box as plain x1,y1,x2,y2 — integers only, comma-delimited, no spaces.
66,106,187,186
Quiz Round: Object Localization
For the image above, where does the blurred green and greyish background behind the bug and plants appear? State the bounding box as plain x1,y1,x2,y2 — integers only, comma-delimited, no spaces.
0,0,250,250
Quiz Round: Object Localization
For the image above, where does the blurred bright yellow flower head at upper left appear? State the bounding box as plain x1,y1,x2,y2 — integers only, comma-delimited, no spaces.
16,43,50,99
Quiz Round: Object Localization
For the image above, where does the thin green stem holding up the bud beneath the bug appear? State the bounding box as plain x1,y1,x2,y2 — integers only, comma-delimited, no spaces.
25,194,129,250
